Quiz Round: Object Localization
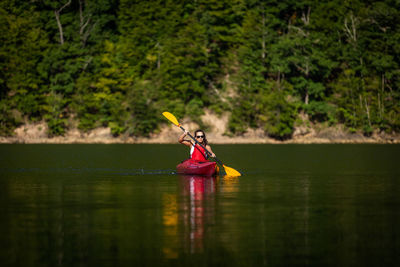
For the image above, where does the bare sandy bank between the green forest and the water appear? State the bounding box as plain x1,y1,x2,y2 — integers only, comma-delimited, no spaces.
0,121,400,144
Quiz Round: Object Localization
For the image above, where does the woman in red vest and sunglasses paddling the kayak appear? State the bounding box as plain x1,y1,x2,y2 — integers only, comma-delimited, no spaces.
178,130,215,161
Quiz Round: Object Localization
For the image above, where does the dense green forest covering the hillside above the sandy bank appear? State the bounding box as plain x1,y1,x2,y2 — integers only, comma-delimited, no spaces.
0,0,400,140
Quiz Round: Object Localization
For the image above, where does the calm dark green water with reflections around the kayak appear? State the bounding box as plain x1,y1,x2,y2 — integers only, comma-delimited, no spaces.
0,145,400,266
